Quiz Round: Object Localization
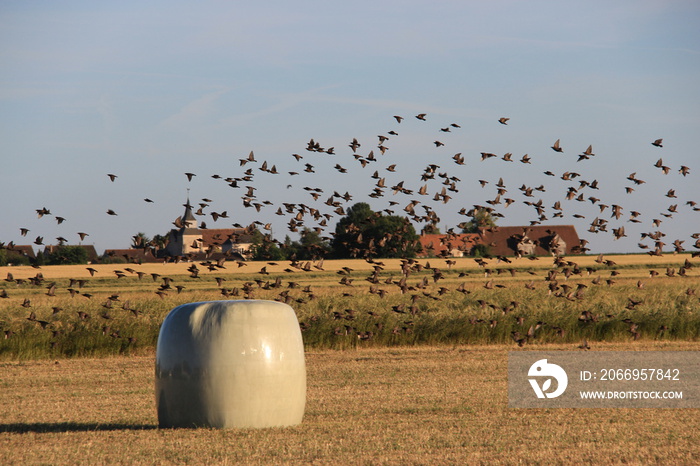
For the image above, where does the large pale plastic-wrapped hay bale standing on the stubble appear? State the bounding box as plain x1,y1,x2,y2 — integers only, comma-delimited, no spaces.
155,300,306,428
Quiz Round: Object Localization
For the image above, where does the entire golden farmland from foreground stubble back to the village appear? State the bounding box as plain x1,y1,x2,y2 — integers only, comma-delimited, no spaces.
0,255,700,464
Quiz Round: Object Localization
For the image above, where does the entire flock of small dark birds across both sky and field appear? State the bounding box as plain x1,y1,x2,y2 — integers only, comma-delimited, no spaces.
0,113,700,349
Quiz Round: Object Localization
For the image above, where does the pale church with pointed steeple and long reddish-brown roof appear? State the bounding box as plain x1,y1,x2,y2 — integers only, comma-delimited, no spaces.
164,199,253,259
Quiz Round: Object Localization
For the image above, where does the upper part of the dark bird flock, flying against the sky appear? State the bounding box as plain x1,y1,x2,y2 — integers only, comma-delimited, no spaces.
0,113,700,254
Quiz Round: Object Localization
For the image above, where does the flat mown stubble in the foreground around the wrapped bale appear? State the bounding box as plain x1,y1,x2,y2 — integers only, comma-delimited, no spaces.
0,342,700,464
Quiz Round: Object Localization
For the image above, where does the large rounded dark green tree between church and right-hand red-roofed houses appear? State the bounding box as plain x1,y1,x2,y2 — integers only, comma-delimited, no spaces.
331,202,420,258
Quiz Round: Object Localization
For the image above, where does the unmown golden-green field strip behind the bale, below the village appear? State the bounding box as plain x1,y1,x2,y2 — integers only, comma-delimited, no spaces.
0,254,700,360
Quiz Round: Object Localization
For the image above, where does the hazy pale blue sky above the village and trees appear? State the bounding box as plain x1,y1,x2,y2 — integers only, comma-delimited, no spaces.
0,1,700,252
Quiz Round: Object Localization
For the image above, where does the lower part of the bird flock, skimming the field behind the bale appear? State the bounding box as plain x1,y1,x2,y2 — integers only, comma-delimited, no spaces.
0,248,697,349
